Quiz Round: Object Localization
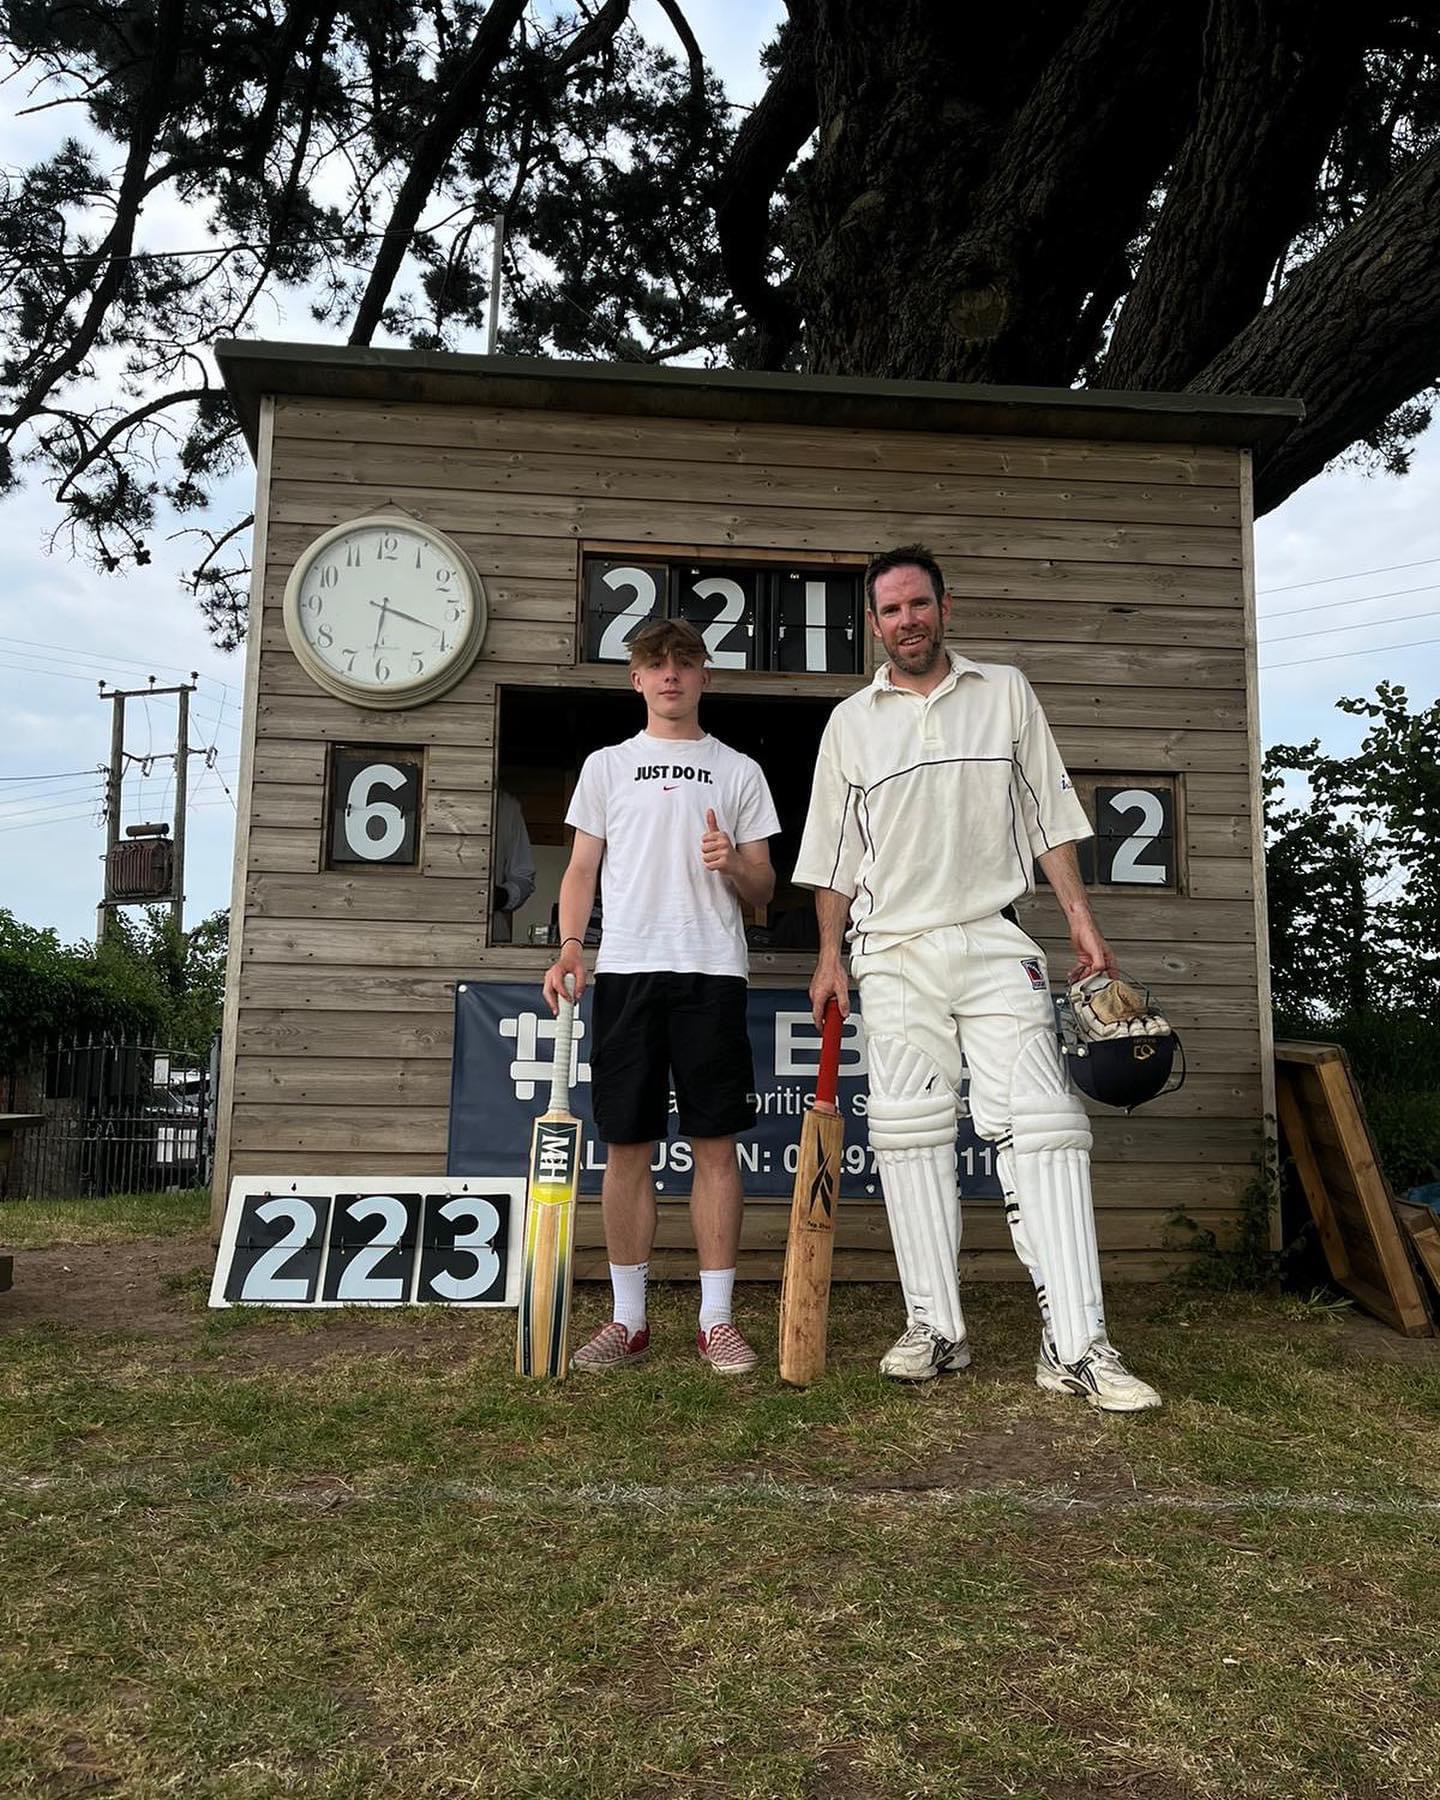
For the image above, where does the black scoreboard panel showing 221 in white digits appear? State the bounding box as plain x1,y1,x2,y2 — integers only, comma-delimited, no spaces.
580,553,866,675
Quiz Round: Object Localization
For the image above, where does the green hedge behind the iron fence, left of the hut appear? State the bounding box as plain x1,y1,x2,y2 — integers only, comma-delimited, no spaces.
0,907,229,1069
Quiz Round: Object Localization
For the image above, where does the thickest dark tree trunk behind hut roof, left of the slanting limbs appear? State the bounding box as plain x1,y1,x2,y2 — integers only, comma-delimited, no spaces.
790,0,1201,383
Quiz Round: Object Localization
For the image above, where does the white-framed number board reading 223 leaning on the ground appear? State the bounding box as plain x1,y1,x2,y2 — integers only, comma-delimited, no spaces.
211,1175,526,1307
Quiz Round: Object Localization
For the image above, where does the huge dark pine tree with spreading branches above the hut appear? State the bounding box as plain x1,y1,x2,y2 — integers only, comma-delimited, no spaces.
0,0,1440,641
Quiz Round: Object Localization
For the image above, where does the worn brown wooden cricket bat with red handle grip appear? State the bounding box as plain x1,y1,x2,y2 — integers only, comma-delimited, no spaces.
779,1001,844,1388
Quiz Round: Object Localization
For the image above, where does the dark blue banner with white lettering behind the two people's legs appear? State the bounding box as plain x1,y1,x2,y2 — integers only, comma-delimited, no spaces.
448,981,1001,1201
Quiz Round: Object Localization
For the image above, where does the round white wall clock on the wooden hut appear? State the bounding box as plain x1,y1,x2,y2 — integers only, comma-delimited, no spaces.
284,515,486,706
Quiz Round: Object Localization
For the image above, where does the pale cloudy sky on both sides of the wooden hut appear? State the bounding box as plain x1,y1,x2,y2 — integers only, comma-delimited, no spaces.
0,0,1440,941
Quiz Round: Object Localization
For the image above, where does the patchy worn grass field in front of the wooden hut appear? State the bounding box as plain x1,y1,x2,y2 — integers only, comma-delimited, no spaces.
0,1201,1440,1800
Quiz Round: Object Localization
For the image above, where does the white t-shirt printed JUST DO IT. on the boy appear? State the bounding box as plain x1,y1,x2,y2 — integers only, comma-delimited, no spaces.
565,731,779,976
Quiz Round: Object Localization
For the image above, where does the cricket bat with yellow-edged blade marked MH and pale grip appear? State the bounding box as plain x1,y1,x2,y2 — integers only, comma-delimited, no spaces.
515,976,580,1377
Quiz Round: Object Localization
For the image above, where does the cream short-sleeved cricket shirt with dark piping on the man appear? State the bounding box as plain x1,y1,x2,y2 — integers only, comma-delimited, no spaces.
794,652,1091,950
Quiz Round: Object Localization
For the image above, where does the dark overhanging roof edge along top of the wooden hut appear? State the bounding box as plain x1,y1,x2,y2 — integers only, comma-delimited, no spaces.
214,338,1305,452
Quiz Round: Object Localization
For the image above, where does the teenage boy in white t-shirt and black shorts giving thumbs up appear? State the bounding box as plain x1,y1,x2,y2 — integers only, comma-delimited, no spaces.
545,619,779,1375
